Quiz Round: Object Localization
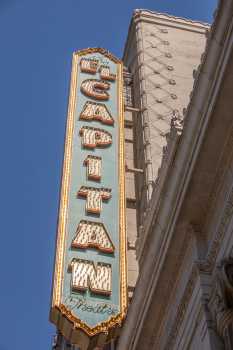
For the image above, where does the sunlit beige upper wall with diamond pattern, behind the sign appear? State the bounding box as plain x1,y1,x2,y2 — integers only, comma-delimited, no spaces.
124,10,208,241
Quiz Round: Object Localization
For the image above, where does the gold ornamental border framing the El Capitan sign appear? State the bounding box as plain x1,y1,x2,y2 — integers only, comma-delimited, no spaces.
51,48,128,336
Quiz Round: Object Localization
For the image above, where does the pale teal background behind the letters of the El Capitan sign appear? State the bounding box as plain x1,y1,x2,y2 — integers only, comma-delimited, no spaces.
62,53,120,327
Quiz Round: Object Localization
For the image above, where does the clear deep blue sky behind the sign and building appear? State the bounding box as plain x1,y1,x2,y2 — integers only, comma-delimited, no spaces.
0,0,216,350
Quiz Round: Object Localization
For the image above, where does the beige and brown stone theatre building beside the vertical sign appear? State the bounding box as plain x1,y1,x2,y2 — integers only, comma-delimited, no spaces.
53,0,233,350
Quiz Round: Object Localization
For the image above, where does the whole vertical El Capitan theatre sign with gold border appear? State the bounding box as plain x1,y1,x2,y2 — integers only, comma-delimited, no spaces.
51,49,127,346
